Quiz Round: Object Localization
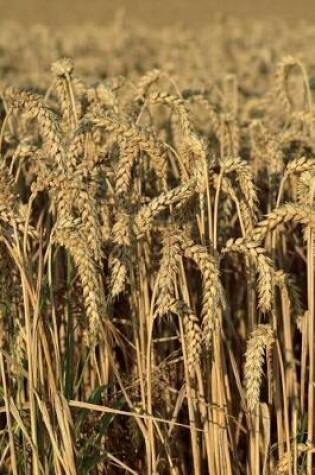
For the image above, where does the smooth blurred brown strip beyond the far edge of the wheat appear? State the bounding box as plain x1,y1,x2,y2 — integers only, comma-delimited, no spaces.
0,0,315,27
